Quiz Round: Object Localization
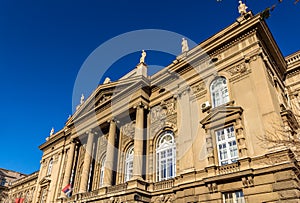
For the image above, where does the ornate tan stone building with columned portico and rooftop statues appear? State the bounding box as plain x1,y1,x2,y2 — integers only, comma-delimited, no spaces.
2,6,300,203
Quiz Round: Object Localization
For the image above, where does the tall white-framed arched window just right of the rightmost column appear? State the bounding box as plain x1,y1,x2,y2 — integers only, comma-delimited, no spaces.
156,130,176,181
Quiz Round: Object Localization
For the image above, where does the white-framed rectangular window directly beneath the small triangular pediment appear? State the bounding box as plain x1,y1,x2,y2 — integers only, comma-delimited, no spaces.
216,126,238,166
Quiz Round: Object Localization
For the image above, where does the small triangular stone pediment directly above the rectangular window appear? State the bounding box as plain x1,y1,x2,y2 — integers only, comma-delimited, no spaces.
200,106,243,128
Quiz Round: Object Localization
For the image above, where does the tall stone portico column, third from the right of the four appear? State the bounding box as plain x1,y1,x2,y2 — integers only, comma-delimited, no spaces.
79,131,94,193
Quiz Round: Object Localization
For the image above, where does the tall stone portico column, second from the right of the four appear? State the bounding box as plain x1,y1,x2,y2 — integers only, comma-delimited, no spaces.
103,120,116,186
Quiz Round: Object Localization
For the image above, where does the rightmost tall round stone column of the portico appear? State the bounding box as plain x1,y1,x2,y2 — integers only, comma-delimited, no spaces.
133,105,144,179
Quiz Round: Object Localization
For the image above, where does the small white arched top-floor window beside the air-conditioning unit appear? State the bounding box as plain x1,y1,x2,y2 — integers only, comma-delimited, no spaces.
210,77,229,107
